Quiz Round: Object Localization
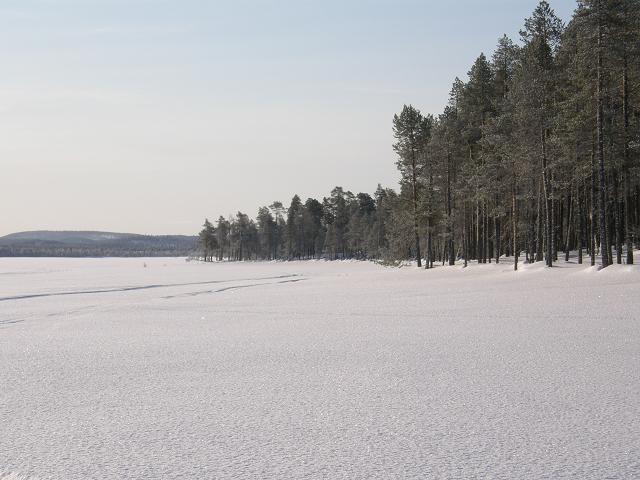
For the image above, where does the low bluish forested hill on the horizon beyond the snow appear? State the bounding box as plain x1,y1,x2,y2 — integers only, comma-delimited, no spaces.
0,230,198,257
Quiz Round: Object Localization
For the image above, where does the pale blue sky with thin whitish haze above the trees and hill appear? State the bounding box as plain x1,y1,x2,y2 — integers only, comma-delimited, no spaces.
0,0,575,235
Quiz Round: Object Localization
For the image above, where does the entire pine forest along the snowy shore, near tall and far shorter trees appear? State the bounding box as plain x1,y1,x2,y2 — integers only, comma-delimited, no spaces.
200,0,640,269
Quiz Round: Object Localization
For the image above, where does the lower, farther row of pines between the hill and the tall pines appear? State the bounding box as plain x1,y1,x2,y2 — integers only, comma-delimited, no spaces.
200,187,384,261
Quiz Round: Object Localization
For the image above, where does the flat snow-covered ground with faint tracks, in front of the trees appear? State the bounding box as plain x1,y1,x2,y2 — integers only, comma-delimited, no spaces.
0,259,640,480
